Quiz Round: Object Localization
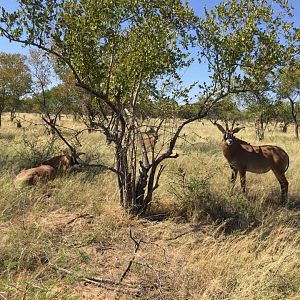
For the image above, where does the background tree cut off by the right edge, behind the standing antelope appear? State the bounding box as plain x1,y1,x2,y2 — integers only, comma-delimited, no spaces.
278,60,300,139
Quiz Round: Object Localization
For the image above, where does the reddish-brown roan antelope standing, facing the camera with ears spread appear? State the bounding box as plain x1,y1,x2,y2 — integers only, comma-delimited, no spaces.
214,122,289,202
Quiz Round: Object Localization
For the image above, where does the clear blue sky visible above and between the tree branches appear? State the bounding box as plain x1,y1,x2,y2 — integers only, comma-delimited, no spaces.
0,0,300,93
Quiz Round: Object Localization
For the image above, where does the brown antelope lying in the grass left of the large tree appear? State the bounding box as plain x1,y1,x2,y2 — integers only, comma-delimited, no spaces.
15,154,80,185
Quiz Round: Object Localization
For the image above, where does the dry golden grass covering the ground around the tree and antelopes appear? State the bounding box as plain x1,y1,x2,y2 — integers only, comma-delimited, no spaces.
0,115,300,300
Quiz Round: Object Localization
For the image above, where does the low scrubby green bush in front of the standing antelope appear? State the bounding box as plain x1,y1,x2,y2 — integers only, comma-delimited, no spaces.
172,170,263,232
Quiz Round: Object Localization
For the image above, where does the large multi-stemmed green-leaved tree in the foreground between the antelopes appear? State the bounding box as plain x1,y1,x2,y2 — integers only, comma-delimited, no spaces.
1,0,294,215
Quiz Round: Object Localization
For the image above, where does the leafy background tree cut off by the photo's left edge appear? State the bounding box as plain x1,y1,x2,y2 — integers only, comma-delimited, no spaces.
0,52,31,127
